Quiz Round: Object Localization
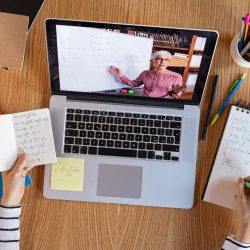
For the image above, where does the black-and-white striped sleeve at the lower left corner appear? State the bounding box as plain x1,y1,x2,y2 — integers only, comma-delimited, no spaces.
0,205,21,250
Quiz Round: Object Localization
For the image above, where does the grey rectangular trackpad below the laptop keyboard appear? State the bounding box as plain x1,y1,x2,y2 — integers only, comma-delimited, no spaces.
97,164,142,199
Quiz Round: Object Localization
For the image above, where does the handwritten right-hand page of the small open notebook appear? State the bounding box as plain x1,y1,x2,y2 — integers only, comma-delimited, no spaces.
12,109,56,166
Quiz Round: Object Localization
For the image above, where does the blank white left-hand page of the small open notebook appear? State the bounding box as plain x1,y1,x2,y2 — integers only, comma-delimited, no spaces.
0,115,17,172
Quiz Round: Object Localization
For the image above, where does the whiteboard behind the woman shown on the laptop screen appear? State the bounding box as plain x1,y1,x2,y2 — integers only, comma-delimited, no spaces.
56,25,153,92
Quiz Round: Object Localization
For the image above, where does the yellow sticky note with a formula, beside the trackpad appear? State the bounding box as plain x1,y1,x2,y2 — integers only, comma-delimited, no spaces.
51,157,84,191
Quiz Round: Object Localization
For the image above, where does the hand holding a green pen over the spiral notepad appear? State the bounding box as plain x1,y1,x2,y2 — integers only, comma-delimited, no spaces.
235,176,250,243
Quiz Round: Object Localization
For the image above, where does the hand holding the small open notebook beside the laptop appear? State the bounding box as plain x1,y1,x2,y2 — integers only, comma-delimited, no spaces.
1,154,30,206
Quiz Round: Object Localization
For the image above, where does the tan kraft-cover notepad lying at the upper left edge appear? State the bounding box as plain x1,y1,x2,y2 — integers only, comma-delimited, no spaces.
0,12,29,69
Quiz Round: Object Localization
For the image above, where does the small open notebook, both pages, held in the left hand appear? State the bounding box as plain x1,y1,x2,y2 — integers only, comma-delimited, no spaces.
0,109,56,171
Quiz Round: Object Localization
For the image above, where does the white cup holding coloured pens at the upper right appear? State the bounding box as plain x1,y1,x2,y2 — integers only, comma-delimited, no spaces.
230,14,250,68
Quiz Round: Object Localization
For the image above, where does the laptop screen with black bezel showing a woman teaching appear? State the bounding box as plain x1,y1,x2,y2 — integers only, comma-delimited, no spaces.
46,19,218,103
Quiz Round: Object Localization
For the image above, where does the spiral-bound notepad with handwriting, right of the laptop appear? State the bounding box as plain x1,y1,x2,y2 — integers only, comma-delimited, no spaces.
203,101,250,209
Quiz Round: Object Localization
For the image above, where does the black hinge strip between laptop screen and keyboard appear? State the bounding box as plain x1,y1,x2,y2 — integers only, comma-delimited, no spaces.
66,94,185,109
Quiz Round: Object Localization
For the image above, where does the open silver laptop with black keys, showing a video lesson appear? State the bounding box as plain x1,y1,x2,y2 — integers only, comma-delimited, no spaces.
43,19,218,209
